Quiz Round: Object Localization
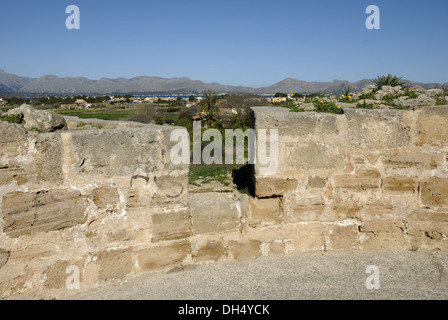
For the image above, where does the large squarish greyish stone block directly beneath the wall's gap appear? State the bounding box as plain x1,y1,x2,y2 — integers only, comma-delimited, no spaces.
188,193,240,234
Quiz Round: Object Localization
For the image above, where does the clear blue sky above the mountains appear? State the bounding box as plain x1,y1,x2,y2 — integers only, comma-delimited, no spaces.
0,0,448,87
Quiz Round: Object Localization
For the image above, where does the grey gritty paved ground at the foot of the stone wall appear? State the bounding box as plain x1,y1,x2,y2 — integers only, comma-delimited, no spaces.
66,251,448,300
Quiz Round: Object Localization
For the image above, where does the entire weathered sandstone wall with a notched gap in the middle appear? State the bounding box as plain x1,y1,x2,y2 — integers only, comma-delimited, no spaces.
0,106,448,299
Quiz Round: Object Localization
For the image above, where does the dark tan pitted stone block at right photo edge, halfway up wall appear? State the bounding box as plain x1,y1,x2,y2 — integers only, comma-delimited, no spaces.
420,178,448,210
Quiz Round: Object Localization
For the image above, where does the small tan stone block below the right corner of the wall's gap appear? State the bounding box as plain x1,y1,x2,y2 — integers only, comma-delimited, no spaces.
248,198,282,226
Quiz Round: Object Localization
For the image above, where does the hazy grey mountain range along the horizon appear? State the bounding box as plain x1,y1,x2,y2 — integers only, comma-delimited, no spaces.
0,70,440,96
